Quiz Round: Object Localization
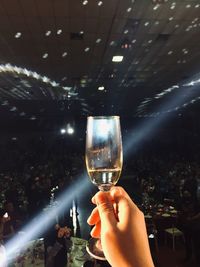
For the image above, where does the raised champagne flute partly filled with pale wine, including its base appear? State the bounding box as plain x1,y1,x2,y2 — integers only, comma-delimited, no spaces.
85,116,123,260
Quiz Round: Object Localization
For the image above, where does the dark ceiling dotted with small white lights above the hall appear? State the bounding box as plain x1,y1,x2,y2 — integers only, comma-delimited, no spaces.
0,0,200,132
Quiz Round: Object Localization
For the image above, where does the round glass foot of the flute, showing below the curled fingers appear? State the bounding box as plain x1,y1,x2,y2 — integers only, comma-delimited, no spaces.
86,238,106,261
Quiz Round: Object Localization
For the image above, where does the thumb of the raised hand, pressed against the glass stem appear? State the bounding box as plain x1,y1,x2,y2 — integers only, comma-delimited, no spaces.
95,191,117,227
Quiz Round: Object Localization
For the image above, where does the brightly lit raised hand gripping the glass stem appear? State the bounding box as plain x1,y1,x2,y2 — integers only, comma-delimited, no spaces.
88,187,154,267
